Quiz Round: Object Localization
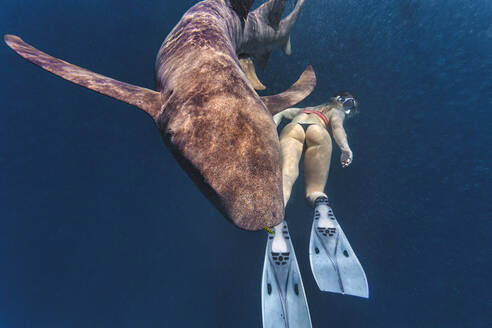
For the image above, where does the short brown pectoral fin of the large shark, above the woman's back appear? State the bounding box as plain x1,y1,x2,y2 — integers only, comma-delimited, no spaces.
261,65,316,115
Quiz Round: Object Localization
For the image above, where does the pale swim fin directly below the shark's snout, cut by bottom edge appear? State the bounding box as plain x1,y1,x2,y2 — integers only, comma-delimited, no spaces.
261,222,312,328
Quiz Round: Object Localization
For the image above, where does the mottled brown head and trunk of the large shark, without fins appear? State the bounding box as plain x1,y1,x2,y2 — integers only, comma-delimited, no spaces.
156,7,284,230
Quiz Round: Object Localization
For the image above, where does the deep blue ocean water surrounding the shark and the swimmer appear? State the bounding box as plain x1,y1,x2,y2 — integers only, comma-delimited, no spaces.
0,0,492,328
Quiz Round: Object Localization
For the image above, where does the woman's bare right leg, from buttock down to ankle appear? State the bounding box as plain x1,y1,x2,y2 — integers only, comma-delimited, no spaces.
304,125,332,205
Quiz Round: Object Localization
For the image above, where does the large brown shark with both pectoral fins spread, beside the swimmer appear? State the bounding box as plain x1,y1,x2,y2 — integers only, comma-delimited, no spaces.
5,0,316,230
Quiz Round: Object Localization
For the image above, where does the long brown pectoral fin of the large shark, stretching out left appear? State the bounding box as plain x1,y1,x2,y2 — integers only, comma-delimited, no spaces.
4,35,162,118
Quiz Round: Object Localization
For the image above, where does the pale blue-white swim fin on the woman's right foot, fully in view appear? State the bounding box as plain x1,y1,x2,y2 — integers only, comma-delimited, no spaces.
309,197,369,298
